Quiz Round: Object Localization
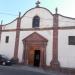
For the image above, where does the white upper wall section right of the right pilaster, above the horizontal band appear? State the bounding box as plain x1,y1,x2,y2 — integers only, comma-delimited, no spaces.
59,16,75,27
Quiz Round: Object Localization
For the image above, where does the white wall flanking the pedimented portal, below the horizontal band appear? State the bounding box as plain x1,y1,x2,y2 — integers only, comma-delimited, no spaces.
18,31,53,65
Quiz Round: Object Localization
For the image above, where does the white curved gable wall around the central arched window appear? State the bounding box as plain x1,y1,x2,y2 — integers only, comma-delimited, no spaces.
21,8,53,28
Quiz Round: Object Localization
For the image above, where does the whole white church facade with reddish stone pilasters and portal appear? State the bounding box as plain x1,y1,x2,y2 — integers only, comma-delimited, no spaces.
0,1,75,68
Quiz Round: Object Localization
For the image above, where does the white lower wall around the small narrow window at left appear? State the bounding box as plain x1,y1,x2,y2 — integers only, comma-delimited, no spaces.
0,32,16,58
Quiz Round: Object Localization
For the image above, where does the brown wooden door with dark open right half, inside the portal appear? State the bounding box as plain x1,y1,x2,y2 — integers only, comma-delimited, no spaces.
28,48,41,67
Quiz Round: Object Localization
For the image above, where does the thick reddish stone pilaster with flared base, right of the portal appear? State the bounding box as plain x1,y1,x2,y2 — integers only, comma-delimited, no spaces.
50,9,60,69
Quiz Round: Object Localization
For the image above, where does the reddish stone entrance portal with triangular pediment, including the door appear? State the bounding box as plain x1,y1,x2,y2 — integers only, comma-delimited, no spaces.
23,32,48,66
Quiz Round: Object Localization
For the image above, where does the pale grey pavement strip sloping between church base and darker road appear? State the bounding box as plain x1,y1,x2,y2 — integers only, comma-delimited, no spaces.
0,65,71,75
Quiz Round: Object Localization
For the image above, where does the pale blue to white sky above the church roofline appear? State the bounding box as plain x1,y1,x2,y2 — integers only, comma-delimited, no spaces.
0,0,75,24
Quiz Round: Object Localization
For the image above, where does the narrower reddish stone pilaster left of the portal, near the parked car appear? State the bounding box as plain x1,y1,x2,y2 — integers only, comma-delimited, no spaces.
13,13,21,62
